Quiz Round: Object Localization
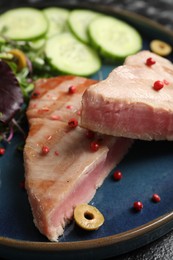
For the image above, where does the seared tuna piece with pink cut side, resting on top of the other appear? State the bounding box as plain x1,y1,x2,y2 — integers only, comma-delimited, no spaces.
81,51,173,140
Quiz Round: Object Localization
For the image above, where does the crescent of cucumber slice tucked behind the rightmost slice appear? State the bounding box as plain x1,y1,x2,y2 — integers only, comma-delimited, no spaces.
68,9,101,43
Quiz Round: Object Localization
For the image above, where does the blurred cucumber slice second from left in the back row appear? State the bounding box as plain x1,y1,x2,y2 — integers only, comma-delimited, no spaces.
43,7,70,38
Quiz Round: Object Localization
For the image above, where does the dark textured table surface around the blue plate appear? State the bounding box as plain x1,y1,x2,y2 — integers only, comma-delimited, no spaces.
0,0,173,260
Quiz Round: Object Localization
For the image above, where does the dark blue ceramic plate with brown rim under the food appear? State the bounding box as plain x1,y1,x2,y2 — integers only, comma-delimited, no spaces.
0,2,173,259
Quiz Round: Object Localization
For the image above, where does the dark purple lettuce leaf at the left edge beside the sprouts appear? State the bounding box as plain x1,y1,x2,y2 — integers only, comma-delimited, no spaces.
0,60,24,123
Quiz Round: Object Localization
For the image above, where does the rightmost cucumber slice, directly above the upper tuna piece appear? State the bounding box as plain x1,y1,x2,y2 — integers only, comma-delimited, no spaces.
89,16,142,59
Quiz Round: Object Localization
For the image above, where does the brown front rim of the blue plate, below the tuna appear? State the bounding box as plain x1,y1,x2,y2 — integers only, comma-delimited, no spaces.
0,211,173,252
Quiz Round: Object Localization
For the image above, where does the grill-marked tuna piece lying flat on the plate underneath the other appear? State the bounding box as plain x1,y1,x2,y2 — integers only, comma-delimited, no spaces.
24,76,132,241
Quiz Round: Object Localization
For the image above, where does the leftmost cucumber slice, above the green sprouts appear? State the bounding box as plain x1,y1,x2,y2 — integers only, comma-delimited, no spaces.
0,7,48,41
